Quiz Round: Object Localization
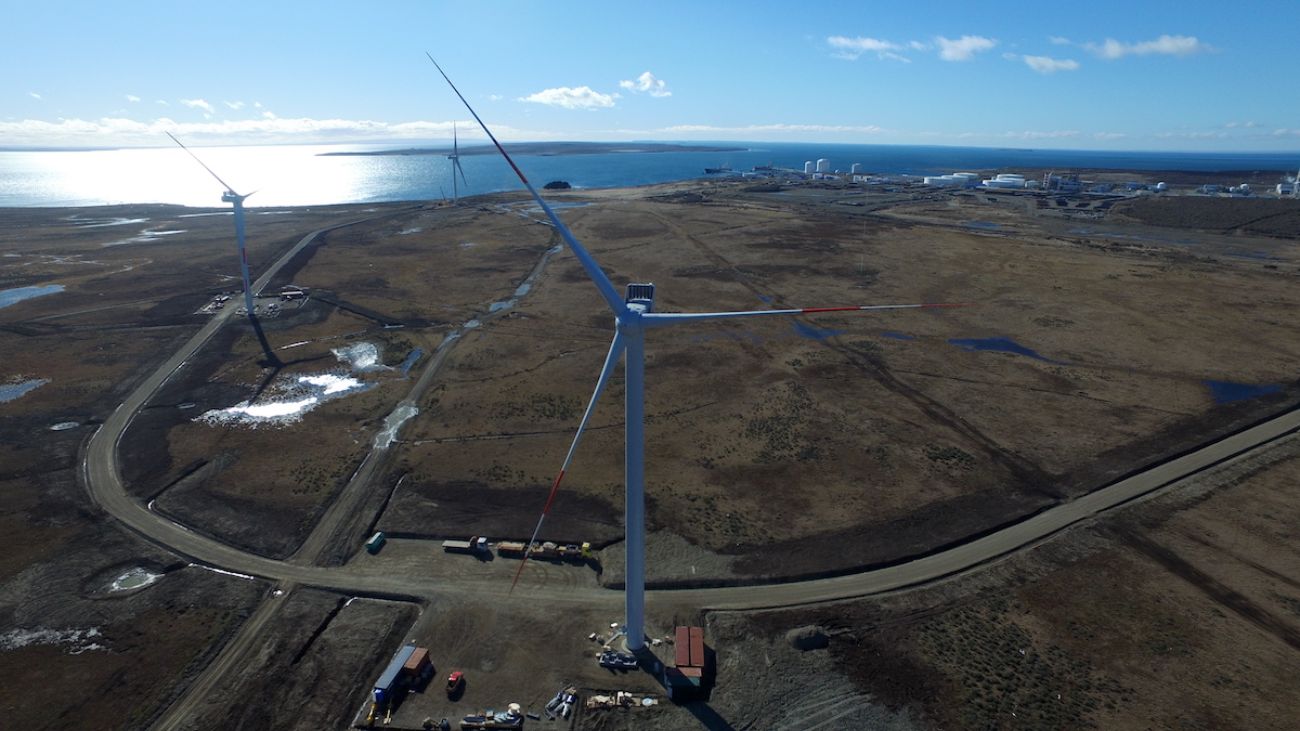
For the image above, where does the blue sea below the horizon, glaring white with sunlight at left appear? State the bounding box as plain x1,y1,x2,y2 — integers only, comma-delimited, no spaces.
0,142,1300,207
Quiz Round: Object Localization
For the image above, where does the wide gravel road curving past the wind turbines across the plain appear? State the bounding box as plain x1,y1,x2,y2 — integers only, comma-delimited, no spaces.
83,214,1300,609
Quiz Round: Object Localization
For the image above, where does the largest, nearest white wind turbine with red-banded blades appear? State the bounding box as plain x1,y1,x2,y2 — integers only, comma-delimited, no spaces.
429,55,963,652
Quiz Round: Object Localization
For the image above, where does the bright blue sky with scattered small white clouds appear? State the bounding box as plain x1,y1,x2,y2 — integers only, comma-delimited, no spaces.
0,0,1300,152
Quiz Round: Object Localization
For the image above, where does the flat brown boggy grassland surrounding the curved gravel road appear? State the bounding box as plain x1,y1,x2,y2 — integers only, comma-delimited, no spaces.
0,182,1300,728
